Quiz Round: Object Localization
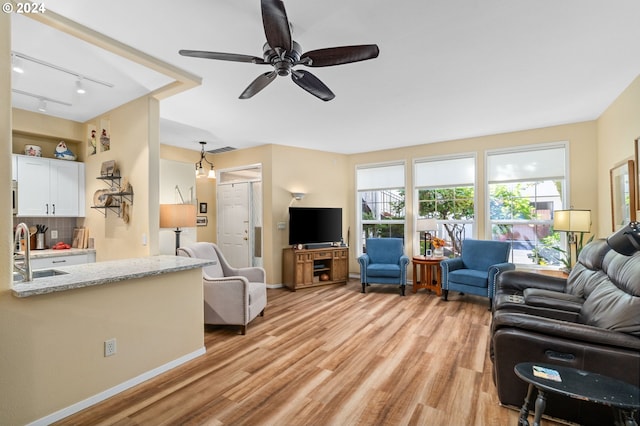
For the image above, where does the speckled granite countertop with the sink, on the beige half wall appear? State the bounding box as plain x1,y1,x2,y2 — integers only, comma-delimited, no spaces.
12,255,216,297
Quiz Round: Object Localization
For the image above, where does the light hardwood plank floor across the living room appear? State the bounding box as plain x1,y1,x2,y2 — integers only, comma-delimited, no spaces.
58,281,558,426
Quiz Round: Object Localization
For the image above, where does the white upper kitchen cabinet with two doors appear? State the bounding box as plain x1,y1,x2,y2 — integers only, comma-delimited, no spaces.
16,155,85,217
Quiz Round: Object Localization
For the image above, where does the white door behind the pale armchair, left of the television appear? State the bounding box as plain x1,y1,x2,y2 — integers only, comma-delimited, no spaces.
218,182,251,268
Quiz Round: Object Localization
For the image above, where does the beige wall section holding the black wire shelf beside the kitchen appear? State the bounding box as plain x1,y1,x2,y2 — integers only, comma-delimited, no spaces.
84,96,160,261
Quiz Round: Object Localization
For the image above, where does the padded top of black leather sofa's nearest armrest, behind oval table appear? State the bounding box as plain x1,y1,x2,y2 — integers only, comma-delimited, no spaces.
492,311,640,351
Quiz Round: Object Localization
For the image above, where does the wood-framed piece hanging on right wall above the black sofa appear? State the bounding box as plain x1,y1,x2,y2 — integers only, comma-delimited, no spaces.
609,160,637,232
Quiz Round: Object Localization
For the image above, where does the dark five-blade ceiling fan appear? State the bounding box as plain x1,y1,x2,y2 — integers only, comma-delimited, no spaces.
178,0,380,101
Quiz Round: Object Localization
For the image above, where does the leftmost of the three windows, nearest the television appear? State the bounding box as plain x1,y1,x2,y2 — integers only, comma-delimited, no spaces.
356,163,405,253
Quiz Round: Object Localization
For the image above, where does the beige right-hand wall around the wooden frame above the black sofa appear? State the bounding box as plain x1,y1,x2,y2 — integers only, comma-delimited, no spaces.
596,76,640,236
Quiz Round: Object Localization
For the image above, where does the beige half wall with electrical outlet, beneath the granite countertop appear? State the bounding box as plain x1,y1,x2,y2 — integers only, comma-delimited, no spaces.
0,269,204,425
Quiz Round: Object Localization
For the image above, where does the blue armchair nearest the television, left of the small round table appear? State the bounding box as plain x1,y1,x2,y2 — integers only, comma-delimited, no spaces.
358,238,409,296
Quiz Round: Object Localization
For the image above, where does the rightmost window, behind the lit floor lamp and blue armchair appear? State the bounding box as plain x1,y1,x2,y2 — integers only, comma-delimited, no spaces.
487,144,566,265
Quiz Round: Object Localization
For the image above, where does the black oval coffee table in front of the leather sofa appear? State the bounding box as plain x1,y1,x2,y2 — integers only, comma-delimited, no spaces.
514,362,640,426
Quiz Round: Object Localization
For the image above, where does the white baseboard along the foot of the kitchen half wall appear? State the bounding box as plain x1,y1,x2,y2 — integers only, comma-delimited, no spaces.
28,346,207,426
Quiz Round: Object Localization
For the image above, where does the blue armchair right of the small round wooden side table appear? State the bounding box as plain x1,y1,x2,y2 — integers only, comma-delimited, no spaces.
440,240,516,309
